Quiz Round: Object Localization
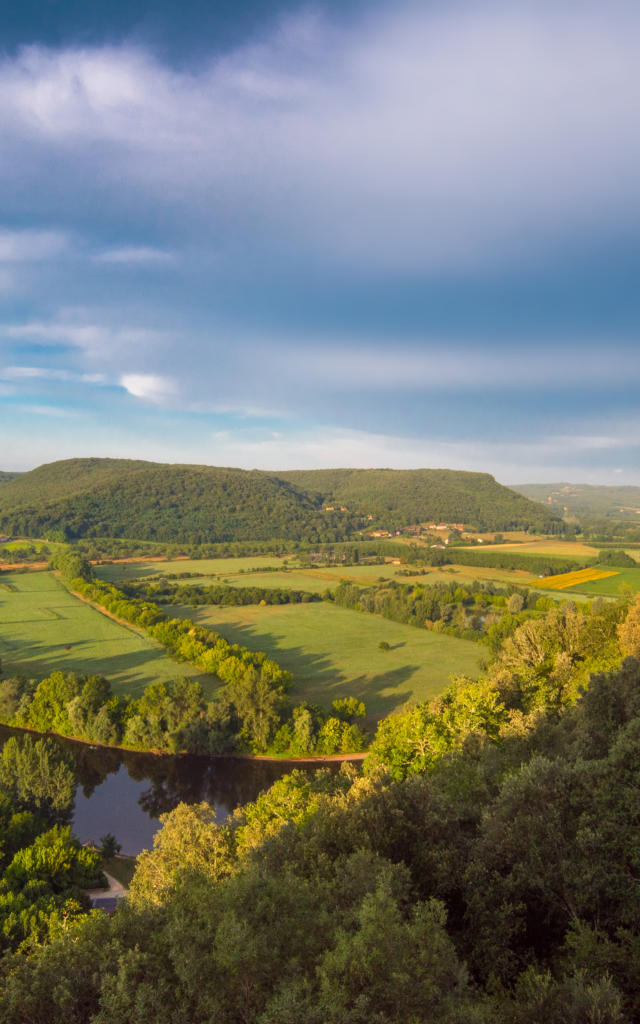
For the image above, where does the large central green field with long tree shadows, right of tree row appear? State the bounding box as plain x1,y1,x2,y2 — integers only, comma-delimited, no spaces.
168,603,484,720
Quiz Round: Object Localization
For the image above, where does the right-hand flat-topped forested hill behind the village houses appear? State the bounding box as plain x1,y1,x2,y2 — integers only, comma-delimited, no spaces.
279,469,553,530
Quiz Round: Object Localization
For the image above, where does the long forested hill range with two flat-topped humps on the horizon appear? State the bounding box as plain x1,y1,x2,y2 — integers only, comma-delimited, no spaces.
0,459,557,544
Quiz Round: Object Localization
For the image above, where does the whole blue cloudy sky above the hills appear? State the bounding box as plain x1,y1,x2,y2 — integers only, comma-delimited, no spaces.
0,0,640,484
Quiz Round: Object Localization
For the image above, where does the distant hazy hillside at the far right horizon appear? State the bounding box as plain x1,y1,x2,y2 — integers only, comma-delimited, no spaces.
513,483,640,523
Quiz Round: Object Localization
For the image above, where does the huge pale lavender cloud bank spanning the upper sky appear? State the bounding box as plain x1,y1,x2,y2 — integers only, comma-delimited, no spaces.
0,0,640,270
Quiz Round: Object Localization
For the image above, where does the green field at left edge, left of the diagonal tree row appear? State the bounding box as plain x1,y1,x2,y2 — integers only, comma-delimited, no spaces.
0,572,206,696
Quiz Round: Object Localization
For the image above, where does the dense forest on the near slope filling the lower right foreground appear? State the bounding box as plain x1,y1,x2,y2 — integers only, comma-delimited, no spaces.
0,597,640,1024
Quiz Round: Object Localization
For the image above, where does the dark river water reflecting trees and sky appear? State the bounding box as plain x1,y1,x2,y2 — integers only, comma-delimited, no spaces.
0,726,311,855
